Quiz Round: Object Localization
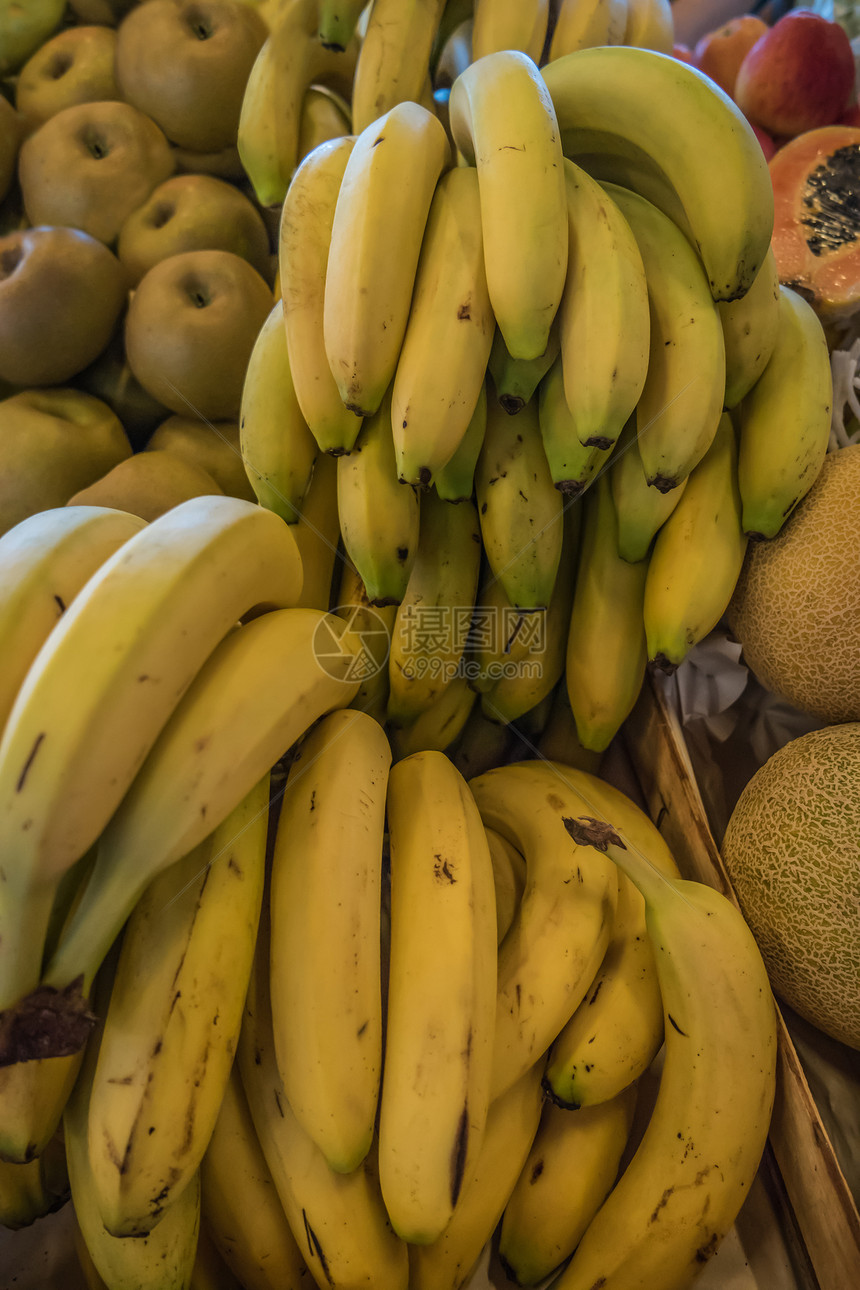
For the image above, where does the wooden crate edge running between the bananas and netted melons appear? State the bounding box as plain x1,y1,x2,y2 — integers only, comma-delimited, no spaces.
624,677,860,1290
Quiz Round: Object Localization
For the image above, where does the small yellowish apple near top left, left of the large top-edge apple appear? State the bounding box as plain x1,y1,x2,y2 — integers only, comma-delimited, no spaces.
15,27,120,129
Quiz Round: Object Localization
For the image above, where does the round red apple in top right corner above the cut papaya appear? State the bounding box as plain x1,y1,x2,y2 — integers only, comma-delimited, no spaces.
735,9,855,138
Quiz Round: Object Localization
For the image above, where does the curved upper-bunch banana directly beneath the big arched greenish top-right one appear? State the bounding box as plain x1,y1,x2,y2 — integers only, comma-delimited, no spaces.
605,184,726,491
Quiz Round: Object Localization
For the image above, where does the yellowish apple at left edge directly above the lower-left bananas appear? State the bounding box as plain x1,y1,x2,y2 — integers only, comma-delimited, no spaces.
0,387,132,533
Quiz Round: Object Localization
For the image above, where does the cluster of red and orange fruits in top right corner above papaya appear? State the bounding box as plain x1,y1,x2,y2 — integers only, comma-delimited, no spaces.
674,9,860,160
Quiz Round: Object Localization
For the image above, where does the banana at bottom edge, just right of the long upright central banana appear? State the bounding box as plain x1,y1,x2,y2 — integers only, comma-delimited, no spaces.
409,1062,543,1290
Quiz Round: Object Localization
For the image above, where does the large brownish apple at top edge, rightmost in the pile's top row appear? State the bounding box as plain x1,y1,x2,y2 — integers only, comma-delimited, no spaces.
116,0,268,152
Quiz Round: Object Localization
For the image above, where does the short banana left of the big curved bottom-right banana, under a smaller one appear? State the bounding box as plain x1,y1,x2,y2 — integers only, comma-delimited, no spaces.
499,1085,636,1286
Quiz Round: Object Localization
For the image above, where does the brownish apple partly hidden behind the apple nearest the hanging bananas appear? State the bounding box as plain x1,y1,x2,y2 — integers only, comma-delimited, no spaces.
116,174,271,285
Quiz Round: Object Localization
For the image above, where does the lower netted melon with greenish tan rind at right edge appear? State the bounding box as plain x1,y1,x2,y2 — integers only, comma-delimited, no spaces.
722,721,860,1049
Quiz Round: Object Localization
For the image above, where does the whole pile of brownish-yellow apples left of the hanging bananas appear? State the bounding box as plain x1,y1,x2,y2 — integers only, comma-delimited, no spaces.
0,0,288,533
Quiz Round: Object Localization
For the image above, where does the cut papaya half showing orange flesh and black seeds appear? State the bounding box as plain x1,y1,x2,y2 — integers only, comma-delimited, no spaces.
770,125,860,324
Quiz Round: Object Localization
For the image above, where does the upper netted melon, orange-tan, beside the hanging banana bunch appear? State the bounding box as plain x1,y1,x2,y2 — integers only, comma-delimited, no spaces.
727,444,860,722
